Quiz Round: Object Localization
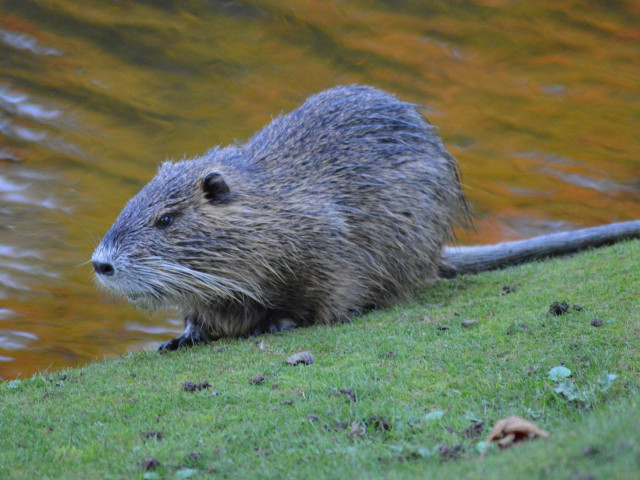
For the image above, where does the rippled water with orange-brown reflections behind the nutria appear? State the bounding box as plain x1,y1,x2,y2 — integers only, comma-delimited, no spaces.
0,0,640,378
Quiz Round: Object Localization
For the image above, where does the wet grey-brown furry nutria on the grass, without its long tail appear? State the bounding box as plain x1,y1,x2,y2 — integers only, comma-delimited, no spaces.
92,85,637,350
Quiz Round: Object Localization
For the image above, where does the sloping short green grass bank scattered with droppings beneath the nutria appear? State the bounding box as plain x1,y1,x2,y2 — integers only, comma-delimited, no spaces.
0,241,640,479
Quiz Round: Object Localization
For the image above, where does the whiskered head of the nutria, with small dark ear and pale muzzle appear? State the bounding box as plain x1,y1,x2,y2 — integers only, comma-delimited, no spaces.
91,149,256,311
